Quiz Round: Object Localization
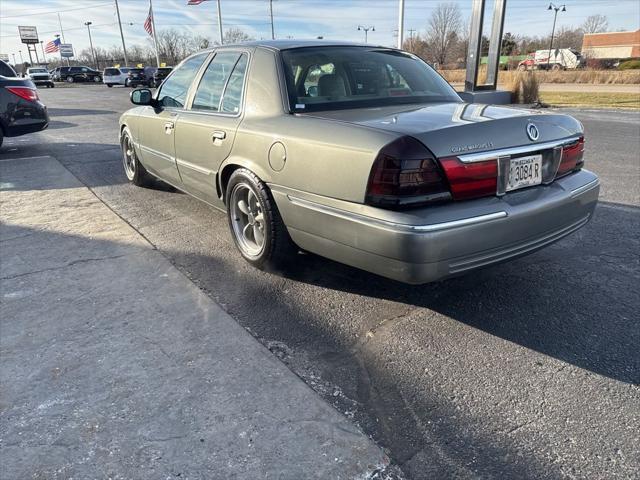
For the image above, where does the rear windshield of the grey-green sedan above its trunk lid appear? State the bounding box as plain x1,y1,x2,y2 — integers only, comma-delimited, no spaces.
282,47,461,112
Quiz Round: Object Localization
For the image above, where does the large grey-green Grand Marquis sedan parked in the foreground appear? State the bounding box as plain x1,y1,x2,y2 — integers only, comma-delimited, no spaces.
119,41,599,283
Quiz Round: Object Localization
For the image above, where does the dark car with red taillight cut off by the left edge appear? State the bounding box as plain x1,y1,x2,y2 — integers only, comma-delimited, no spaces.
0,60,49,147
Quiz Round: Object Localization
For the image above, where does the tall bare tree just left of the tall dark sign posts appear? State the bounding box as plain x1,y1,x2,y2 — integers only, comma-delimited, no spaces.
426,3,462,65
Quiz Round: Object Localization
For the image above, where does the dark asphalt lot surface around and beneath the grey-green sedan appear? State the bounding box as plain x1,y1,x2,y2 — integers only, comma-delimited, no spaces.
0,85,640,479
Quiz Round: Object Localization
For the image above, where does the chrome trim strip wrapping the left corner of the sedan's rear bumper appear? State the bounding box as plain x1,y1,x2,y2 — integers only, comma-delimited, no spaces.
287,195,507,233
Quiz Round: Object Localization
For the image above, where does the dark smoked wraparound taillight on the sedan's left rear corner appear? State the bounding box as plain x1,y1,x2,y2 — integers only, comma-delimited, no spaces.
366,137,451,207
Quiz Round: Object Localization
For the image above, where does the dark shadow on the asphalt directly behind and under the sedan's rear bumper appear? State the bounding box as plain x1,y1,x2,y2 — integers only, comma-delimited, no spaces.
278,203,640,384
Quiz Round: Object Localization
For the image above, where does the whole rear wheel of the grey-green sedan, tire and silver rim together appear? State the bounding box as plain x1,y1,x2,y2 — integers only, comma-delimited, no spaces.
225,168,295,269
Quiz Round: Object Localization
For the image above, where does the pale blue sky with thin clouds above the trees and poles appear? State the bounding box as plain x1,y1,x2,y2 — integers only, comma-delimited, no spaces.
0,0,640,62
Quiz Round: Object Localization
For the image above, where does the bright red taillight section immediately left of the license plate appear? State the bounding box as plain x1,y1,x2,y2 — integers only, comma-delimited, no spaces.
440,157,498,200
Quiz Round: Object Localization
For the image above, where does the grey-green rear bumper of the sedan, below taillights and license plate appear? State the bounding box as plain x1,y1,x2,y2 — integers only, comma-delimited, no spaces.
271,170,599,284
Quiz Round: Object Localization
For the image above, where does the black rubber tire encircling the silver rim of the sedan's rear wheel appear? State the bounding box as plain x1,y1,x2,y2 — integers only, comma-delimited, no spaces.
225,168,297,270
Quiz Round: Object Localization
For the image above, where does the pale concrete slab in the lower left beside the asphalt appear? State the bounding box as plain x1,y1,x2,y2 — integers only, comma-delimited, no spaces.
0,157,388,480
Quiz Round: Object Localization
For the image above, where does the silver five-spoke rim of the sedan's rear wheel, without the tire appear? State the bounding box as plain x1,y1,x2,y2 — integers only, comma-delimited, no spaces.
229,183,265,256
